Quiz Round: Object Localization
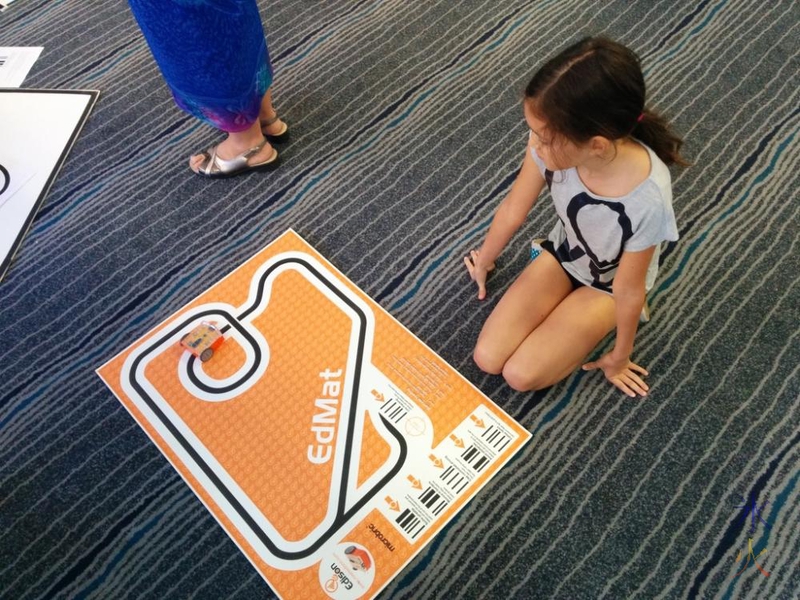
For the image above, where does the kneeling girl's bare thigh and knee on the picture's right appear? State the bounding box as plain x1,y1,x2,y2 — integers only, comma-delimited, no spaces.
503,287,616,391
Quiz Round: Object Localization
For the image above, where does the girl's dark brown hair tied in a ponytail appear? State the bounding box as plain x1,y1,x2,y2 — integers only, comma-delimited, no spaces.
525,37,689,166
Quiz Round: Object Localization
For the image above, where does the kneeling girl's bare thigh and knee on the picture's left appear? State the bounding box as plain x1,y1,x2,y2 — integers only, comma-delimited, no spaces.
474,252,572,375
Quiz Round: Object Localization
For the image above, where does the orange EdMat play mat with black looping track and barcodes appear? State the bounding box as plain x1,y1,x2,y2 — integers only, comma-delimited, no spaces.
98,231,530,599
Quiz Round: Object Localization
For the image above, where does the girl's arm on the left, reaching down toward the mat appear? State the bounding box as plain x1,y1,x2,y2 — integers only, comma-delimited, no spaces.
464,148,544,300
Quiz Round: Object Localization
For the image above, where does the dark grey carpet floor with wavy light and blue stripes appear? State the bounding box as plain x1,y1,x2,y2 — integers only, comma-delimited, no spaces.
0,0,800,600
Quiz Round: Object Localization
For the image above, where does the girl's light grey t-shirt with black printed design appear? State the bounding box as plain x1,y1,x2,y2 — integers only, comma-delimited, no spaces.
531,142,678,292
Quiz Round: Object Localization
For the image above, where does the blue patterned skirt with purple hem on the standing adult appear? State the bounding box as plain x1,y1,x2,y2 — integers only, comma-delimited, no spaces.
128,0,272,132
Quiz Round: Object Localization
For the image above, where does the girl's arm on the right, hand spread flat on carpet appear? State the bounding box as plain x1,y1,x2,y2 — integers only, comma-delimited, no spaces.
583,246,655,397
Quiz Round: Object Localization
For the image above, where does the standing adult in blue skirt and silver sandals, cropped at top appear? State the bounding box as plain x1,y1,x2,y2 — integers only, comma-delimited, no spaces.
129,0,288,178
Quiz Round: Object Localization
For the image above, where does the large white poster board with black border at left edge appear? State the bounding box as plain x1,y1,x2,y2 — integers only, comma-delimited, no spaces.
0,89,99,280
